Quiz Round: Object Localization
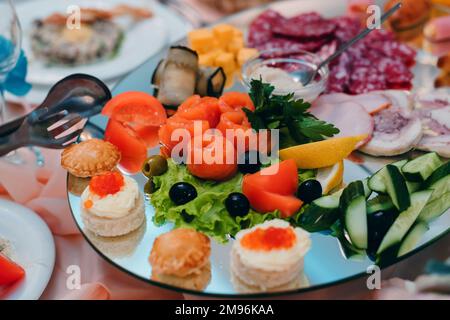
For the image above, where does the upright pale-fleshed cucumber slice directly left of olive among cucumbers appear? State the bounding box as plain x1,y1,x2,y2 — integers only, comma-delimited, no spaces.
339,181,368,249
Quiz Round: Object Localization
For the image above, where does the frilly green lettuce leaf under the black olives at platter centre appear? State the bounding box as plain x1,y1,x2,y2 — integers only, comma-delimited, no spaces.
150,160,280,243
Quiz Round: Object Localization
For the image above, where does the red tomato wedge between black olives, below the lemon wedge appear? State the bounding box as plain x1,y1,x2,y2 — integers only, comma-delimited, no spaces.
244,159,298,195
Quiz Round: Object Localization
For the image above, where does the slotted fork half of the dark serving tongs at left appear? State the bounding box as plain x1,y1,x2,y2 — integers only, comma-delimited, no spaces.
0,109,85,156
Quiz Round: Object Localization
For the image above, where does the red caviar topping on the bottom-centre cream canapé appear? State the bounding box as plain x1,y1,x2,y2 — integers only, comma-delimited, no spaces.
241,227,297,251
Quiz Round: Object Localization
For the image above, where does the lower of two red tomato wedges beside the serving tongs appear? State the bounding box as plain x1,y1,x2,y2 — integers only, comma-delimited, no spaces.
105,119,147,174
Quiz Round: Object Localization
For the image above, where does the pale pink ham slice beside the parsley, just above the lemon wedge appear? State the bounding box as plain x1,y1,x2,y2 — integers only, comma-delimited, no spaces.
310,101,373,147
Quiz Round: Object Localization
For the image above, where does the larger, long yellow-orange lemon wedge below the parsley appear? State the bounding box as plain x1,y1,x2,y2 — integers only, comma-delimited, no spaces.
279,135,367,169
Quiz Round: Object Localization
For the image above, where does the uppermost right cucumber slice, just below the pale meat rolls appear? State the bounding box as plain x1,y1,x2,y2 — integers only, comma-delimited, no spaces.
402,152,442,182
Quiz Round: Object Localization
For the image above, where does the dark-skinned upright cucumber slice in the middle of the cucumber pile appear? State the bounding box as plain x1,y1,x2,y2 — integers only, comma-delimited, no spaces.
383,164,411,211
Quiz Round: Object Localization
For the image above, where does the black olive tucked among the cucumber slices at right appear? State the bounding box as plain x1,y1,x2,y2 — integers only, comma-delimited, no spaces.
367,211,396,252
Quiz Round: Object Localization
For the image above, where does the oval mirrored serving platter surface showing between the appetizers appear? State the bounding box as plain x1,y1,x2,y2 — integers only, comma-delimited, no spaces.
68,0,450,297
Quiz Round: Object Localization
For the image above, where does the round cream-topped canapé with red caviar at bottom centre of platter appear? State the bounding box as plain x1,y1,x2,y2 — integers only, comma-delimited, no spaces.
231,219,311,291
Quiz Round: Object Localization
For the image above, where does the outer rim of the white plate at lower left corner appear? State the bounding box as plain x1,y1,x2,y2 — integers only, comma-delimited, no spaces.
0,198,55,300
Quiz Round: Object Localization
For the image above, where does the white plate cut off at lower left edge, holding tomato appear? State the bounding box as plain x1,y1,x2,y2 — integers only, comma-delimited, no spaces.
0,199,55,300
